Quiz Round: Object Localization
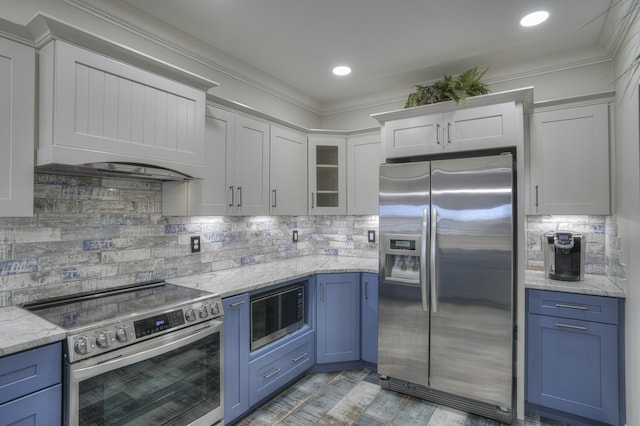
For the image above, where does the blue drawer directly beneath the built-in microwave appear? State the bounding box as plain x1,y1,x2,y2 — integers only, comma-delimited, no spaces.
249,329,315,406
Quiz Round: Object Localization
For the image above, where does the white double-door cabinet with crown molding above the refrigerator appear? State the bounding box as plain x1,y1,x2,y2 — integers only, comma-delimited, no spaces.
372,88,533,159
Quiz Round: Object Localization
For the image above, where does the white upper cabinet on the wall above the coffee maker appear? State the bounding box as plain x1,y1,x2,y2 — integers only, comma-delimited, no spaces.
529,99,610,215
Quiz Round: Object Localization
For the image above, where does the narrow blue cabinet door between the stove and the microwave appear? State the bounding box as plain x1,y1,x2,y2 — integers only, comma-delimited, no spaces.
222,293,249,424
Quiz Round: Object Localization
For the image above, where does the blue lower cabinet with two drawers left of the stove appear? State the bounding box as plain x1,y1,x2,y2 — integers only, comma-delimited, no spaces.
0,342,62,426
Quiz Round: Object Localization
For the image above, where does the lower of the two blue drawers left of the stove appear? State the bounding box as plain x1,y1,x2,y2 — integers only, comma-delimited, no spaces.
0,384,62,426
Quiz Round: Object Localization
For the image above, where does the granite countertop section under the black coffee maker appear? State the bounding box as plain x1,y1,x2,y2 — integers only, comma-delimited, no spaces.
524,270,625,298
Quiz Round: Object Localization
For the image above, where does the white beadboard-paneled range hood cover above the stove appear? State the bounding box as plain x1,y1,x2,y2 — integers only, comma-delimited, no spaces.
37,40,205,177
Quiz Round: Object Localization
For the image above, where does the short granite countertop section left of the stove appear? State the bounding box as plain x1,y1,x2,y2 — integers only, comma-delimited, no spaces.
0,306,66,356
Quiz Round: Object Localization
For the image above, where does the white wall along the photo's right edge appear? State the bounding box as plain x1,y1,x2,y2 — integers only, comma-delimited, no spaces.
614,2,640,425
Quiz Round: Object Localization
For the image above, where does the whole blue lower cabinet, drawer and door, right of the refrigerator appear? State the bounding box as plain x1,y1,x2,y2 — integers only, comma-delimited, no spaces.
526,290,624,425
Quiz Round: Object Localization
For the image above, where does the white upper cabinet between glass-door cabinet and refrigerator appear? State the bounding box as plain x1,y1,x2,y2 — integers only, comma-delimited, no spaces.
347,132,384,215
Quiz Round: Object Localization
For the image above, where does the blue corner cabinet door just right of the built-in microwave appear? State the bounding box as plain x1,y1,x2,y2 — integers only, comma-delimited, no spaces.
316,273,360,364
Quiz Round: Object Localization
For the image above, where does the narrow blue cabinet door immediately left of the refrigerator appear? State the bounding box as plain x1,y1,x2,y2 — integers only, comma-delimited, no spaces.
360,273,378,364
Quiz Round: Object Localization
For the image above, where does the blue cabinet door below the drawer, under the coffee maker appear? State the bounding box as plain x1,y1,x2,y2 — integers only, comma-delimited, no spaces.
527,314,619,424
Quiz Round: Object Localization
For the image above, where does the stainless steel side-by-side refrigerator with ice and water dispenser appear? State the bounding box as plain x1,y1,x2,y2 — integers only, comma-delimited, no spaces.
378,151,517,423
